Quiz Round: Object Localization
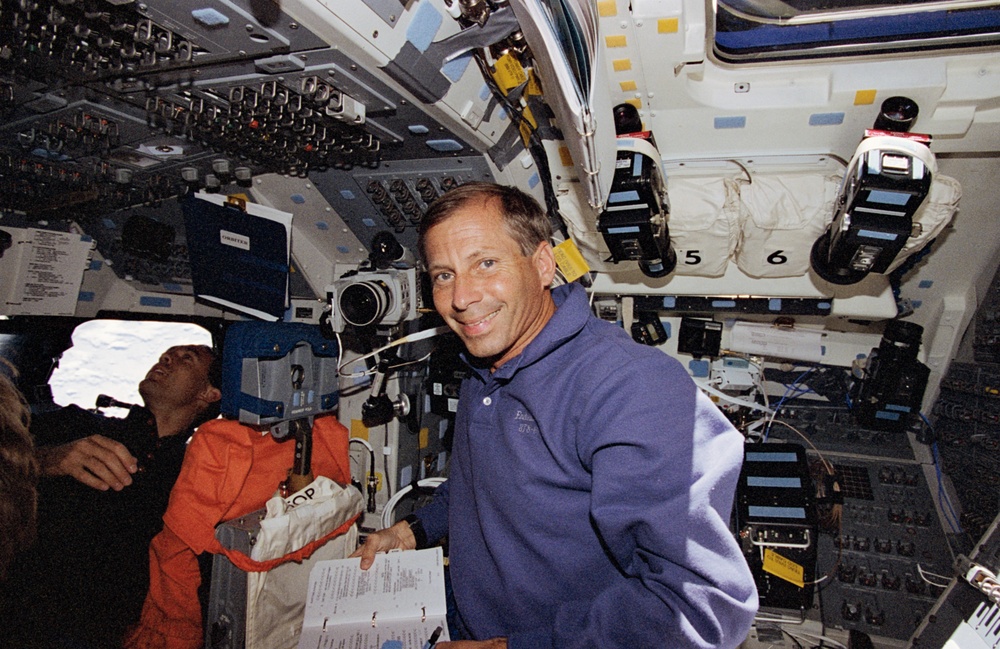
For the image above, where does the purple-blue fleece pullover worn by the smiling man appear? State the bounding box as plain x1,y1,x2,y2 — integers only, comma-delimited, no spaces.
418,284,757,649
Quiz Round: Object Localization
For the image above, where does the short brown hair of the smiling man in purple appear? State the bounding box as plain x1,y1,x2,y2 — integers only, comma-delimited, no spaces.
417,182,552,261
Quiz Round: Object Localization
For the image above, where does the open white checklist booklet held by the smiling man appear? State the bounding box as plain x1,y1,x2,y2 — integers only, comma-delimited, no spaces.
299,548,448,649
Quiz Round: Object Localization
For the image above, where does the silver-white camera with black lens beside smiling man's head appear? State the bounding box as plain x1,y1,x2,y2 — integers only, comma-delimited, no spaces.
326,268,417,333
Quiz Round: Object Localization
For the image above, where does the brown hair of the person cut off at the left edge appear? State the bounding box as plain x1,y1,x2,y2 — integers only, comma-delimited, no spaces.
0,374,39,579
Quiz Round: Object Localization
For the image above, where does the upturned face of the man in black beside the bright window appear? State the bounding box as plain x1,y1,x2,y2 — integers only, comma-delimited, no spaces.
139,345,216,406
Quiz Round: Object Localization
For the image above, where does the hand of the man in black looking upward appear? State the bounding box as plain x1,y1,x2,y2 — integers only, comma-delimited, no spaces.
35,435,139,491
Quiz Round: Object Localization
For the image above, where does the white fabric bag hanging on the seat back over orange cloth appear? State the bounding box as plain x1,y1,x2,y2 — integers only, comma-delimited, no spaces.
246,477,364,649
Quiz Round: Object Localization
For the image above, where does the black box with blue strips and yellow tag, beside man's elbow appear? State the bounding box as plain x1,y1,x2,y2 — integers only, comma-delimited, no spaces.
735,443,818,611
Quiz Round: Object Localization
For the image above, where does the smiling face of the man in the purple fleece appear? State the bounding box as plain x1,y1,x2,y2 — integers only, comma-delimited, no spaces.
424,201,555,369
